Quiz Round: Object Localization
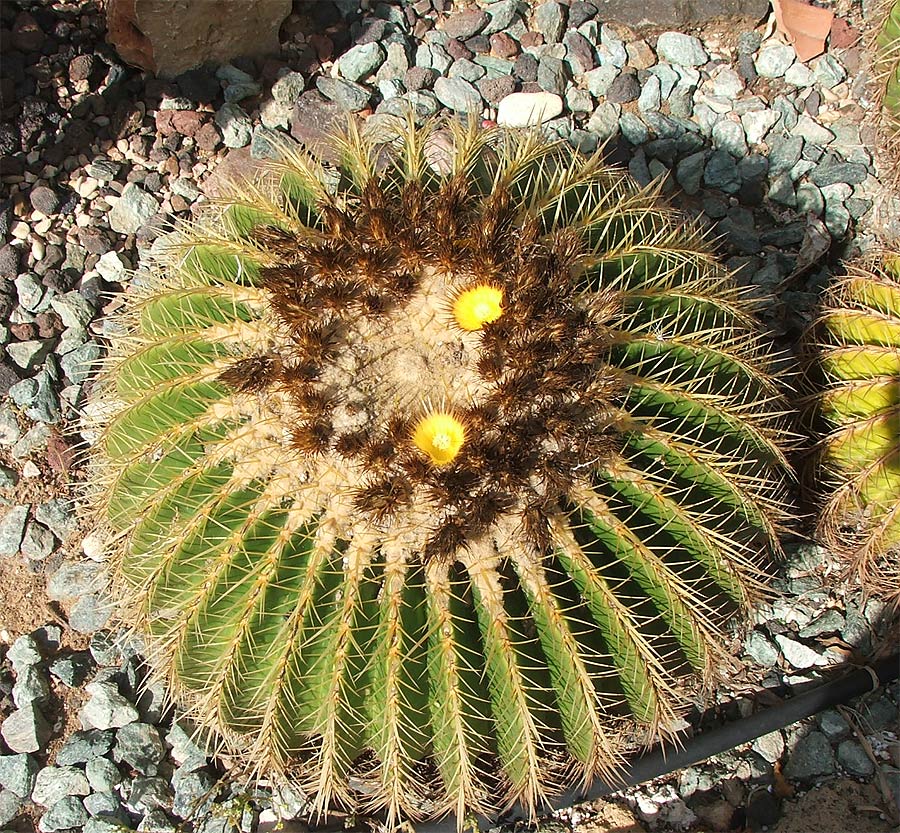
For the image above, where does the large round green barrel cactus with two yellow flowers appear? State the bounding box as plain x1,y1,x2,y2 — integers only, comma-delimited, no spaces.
92,118,785,820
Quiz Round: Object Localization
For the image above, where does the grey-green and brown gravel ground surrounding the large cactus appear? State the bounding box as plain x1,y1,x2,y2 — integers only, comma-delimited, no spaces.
0,0,900,833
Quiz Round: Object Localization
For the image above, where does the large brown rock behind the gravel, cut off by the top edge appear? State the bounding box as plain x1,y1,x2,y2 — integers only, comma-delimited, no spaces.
106,0,291,78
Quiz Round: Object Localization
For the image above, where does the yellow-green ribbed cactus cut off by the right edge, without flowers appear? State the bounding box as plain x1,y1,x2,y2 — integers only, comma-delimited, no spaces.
818,249,900,605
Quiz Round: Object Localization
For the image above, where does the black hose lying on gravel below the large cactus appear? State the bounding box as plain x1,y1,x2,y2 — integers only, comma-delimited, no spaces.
416,654,900,833
